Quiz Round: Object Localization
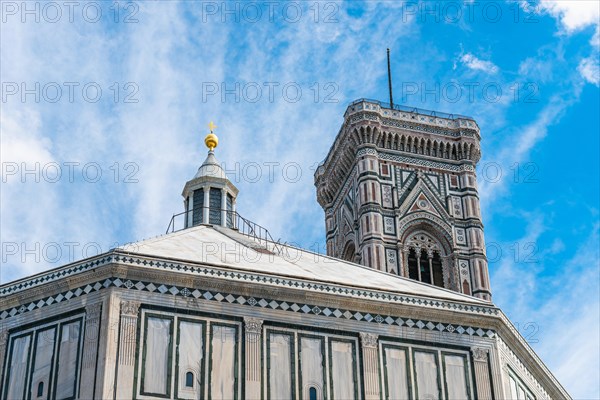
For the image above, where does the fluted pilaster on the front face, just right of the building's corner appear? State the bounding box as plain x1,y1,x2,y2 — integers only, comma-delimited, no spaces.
115,301,140,399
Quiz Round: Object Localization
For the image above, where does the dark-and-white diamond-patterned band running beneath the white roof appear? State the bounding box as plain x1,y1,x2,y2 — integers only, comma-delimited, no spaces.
0,267,495,339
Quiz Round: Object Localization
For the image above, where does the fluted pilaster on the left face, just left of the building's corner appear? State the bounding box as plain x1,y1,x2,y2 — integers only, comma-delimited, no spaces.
79,302,102,399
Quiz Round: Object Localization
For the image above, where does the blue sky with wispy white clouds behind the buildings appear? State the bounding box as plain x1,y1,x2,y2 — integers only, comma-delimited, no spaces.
0,1,600,399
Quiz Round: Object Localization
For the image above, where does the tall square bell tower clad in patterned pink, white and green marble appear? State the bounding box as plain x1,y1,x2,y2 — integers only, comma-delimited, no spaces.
315,99,491,300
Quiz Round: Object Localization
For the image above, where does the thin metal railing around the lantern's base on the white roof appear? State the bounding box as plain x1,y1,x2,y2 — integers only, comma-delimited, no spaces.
165,207,282,254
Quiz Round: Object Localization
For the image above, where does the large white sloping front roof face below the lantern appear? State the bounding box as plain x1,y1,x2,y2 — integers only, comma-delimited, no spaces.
119,225,492,306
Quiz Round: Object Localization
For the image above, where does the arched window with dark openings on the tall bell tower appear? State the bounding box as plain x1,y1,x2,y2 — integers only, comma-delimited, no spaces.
405,233,444,287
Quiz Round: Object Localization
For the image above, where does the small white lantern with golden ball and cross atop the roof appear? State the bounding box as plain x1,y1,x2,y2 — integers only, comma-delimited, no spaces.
182,122,238,228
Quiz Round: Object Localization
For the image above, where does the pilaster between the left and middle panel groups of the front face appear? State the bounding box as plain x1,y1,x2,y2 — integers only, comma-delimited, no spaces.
244,317,263,399
